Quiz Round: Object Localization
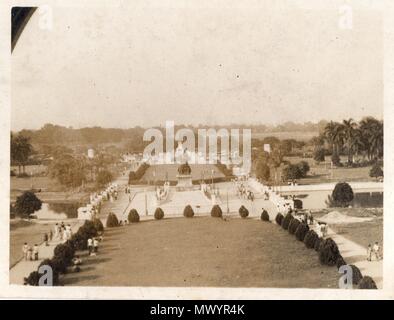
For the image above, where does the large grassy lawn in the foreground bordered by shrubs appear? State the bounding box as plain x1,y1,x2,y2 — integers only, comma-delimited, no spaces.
62,217,338,288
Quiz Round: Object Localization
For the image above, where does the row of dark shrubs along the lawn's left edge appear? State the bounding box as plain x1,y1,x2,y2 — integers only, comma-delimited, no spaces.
25,219,104,286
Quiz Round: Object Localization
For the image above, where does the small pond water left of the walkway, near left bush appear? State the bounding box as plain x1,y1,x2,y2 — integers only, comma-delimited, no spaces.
34,202,81,220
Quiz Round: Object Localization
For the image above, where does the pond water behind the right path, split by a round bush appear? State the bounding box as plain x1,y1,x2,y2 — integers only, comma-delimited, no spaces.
282,190,383,209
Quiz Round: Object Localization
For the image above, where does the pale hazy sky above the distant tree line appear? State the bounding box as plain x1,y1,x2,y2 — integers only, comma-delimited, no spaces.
11,0,383,130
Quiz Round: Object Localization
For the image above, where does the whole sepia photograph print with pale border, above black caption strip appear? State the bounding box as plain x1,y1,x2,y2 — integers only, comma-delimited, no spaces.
1,0,393,298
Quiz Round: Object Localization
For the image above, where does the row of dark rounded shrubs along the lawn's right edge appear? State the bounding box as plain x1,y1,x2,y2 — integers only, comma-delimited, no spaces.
270,213,377,289
